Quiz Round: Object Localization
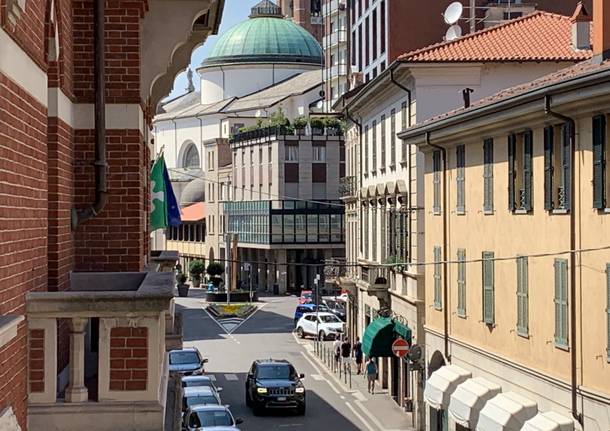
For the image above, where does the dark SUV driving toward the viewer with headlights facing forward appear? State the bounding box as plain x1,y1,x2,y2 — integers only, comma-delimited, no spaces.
246,359,305,415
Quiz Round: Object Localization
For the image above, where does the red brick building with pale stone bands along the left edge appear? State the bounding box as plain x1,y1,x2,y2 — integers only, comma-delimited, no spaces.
0,0,224,430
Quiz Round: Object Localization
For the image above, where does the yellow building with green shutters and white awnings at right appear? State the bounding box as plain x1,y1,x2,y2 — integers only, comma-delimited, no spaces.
400,9,610,430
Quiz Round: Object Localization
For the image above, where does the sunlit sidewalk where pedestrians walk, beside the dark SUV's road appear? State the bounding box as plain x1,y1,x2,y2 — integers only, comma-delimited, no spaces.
302,341,415,431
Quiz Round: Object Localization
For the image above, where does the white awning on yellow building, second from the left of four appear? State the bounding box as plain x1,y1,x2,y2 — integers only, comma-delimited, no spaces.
449,377,502,429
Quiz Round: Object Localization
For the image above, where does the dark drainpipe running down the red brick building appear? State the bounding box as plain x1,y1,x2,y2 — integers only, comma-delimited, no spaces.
72,0,108,229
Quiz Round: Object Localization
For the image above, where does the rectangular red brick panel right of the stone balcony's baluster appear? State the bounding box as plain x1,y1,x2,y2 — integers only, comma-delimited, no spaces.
110,327,148,391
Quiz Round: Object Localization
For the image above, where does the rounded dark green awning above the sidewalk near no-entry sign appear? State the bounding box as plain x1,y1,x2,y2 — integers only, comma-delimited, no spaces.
362,317,411,358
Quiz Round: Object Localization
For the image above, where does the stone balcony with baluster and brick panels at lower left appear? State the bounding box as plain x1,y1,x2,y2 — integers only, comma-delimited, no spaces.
27,268,175,431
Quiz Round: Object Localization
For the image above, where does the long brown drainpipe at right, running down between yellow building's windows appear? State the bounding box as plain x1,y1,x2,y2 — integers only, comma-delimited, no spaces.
544,94,583,425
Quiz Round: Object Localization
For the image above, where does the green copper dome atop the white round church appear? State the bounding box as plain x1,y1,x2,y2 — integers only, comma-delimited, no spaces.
202,16,323,67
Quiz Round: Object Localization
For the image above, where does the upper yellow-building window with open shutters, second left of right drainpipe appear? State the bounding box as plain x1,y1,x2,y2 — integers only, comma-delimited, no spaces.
508,131,533,212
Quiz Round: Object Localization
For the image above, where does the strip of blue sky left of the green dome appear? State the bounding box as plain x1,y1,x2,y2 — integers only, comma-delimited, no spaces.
169,0,260,99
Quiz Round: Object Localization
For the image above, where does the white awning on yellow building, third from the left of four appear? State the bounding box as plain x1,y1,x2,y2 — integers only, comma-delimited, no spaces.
477,392,538,431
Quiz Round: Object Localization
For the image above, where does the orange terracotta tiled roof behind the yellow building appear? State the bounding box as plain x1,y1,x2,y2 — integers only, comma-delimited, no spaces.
398,11,591,63
